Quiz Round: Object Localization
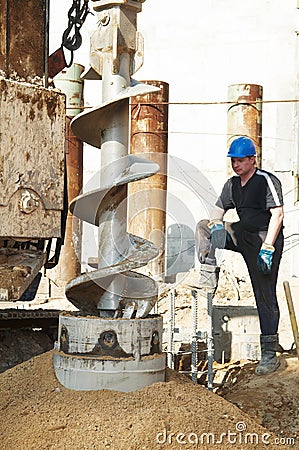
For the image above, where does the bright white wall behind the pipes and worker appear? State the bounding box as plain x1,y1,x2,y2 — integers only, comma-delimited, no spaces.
50,0,299,276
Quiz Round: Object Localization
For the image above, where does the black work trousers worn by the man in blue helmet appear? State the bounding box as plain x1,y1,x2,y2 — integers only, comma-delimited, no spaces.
196,220,284,336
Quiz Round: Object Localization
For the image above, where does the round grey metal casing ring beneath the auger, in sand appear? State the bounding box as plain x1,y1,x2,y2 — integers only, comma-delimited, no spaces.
54,312,166,392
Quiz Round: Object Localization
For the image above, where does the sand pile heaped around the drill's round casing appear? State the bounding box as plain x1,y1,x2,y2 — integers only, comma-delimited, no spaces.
0,351,286,450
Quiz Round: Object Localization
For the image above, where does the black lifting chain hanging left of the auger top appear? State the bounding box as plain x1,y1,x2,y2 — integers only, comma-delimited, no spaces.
62,0,92,67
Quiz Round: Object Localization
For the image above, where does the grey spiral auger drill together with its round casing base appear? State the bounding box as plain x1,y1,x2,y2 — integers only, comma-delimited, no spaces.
54,0,165,391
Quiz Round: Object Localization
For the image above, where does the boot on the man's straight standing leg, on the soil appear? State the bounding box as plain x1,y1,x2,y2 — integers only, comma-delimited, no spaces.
255,334,279,375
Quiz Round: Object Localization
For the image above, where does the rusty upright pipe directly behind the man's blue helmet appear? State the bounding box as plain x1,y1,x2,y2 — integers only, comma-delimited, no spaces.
227,84,263,176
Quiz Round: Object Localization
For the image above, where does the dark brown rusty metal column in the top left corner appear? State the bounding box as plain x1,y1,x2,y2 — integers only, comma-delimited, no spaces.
0,0,46,80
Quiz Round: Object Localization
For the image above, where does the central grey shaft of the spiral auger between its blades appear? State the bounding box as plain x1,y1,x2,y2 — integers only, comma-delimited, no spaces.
98,53,130,268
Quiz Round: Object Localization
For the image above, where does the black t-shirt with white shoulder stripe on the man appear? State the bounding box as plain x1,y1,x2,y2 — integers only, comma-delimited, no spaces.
216,169,283,231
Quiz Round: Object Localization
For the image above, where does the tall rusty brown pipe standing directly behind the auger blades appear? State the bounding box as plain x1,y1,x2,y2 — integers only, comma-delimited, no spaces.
128,80,169,281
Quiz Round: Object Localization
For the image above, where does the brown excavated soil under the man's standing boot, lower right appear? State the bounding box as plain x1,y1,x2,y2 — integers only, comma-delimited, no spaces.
223,354,299,442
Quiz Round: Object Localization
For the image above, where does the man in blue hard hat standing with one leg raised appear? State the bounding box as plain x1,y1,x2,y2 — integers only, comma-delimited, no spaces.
196,136,284,375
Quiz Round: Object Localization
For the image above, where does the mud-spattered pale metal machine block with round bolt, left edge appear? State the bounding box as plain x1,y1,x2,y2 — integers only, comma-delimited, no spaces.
0,78,65,238
